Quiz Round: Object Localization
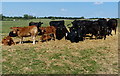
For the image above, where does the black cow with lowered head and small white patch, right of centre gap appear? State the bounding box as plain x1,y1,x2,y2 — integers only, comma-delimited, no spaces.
65,20,86,42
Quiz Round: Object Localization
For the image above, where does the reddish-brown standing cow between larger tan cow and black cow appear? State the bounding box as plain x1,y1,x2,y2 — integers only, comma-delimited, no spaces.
39,26,56,40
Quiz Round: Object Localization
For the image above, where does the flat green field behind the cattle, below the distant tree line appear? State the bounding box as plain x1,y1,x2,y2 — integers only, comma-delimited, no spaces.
0,19,72,33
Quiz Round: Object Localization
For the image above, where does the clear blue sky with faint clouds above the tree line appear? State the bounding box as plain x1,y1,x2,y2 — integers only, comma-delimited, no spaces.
2,2,118,18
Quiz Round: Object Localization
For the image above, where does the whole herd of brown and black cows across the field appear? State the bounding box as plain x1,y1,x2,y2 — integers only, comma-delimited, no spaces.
2,18,117,45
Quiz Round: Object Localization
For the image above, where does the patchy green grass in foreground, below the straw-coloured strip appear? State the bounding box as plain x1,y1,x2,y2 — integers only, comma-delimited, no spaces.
2,46,109,74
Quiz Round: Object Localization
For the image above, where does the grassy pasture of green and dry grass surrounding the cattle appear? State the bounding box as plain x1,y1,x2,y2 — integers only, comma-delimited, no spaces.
2,19,119,74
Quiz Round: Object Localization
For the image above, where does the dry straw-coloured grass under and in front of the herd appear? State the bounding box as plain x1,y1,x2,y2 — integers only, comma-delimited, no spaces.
2,29,119,74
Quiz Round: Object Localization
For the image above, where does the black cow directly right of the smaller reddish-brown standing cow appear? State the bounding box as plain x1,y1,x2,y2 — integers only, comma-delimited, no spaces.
49,20,68,40
